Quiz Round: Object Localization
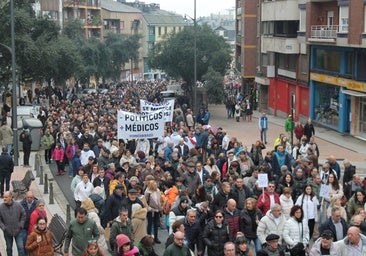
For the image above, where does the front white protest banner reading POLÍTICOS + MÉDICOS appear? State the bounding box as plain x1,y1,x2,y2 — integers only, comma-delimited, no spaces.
117,110,165,139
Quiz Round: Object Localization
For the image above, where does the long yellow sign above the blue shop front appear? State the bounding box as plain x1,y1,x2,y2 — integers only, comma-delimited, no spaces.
310,73,366,92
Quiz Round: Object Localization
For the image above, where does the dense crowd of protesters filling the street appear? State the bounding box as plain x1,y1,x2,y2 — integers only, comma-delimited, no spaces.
0,79,366,256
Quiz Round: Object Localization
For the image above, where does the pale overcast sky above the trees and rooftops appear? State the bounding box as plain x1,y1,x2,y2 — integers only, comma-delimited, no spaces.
145,0,235,18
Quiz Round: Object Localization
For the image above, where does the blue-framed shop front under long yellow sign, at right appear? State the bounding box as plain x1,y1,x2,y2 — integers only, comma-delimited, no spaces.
310,72,366,139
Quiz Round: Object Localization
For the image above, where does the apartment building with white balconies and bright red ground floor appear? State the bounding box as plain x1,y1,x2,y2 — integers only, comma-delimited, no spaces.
253,0,309,120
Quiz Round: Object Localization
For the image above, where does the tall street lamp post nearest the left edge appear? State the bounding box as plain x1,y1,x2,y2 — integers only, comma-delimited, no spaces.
0,0,19,166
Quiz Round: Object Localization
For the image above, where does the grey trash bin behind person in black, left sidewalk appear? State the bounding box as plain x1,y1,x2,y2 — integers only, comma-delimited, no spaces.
18,118,43,151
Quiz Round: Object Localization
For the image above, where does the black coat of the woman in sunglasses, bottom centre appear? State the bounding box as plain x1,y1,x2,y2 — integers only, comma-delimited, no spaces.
203,220,231,256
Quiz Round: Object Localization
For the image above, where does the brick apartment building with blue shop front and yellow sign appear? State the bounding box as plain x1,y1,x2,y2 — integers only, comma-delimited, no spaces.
306,0,366,139
